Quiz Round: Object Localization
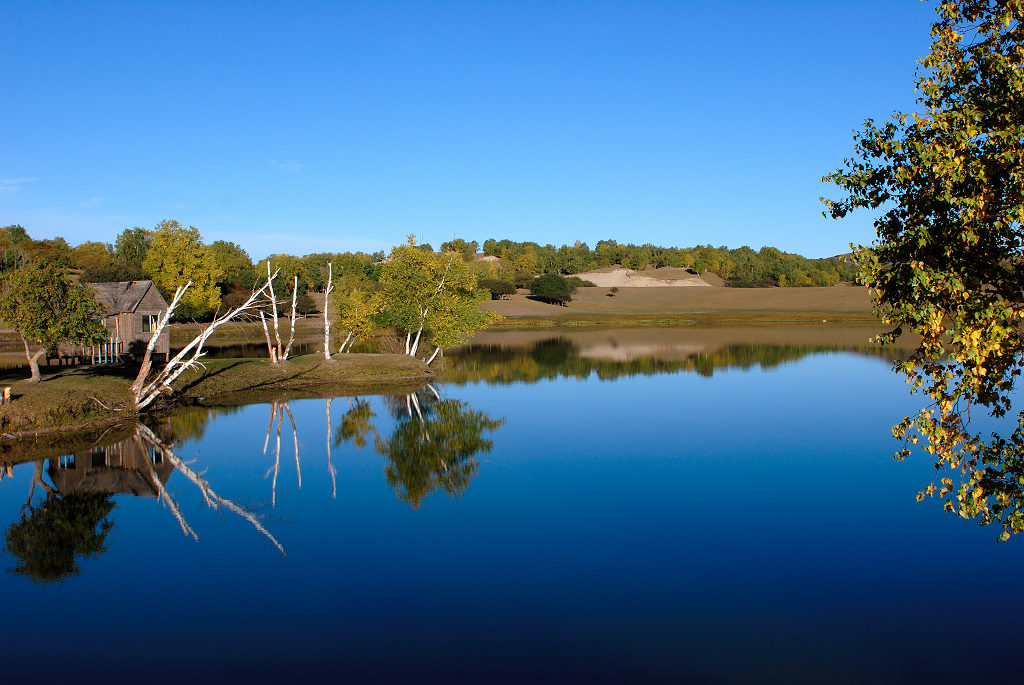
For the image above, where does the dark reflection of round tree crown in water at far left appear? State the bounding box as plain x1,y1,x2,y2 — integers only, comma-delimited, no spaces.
4,493,117,583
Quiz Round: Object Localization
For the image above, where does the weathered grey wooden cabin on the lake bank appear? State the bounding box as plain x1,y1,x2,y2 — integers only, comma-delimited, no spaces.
88,281,171,358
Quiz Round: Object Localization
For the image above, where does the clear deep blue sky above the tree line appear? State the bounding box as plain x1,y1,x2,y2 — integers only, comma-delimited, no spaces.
0,0,934,259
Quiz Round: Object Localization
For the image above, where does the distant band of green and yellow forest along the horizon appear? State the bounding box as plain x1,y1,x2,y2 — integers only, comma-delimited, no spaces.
0,221,855,318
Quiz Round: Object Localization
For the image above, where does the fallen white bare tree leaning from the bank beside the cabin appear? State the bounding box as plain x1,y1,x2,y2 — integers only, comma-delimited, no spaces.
131,271,278,411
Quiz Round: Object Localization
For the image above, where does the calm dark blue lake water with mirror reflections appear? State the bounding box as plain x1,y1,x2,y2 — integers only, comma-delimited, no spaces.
0,330,1024,683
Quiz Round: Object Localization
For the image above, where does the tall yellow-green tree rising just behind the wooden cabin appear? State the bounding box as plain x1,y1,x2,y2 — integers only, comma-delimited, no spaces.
142,220,223,318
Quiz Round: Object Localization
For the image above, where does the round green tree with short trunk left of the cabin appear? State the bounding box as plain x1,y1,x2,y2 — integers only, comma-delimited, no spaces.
0,262,109,382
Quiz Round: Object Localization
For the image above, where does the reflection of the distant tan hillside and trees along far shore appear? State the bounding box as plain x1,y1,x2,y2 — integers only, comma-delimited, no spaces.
444,327,905,384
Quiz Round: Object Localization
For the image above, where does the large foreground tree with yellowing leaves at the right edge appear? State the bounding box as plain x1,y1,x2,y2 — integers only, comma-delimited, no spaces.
824,0,1024,539
